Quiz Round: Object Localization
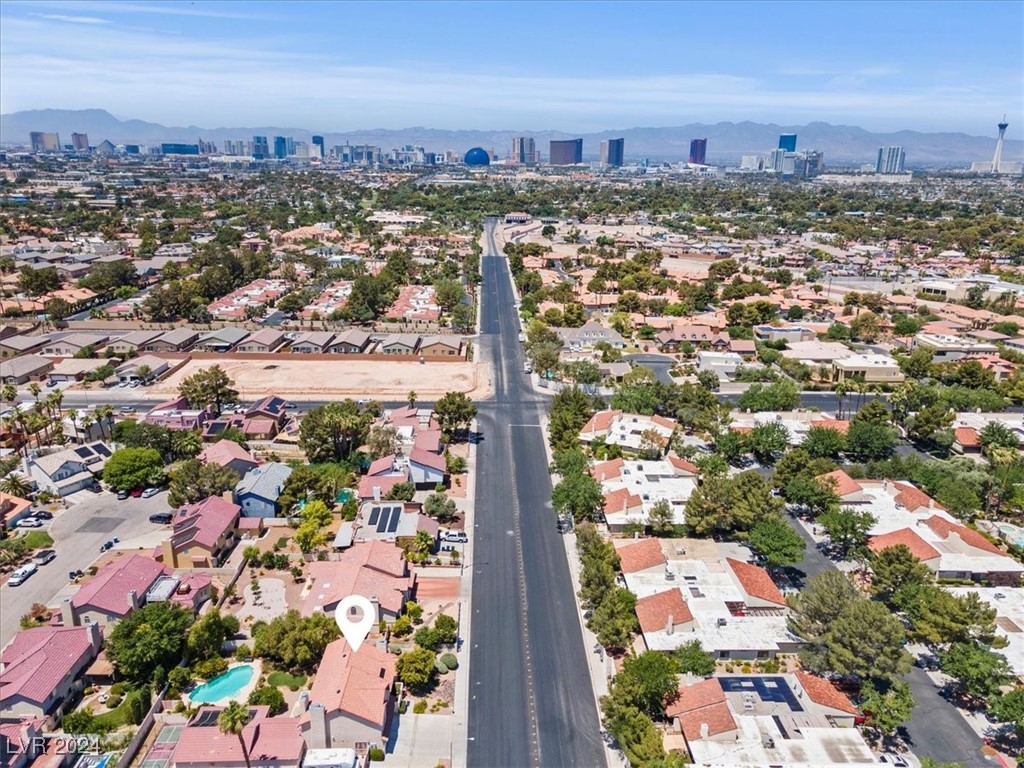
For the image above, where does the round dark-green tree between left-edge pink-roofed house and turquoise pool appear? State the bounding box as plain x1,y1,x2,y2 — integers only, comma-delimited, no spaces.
106,602,193,683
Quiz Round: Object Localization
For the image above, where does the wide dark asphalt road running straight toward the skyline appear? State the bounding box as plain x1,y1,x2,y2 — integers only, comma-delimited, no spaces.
468,219,605,768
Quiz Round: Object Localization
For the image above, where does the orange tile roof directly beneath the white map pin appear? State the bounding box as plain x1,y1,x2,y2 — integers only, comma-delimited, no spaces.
309,639,397,729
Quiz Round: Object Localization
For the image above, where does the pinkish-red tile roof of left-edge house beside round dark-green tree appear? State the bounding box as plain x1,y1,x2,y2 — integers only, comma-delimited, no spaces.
0,627,94,709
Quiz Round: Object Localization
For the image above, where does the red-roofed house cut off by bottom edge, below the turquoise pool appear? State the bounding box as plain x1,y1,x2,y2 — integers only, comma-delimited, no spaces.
165,707,306,768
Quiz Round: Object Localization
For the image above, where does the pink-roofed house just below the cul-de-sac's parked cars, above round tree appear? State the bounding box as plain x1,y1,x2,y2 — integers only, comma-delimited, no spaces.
60,555,169,627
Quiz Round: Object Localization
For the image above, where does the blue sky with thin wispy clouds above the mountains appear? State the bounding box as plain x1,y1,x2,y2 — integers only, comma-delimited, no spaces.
0,0,1024,138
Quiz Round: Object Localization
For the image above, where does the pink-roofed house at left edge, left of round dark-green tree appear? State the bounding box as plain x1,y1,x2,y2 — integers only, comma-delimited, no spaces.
0,625,102,720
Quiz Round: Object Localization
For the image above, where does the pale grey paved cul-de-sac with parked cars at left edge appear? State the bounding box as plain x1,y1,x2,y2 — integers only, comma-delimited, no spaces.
0,490,170,646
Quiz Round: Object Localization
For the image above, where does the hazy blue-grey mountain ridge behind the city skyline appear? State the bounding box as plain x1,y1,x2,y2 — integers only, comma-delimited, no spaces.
0,110,1024,167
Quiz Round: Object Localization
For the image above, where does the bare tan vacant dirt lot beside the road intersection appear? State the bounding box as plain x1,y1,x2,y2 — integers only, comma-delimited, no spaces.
152,355,492,400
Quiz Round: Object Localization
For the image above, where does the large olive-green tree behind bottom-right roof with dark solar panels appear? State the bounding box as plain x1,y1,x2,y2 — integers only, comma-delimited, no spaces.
812,599,911,679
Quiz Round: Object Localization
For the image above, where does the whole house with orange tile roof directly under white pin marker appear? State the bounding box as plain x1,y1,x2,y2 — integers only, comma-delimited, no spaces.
302,639,397,749
